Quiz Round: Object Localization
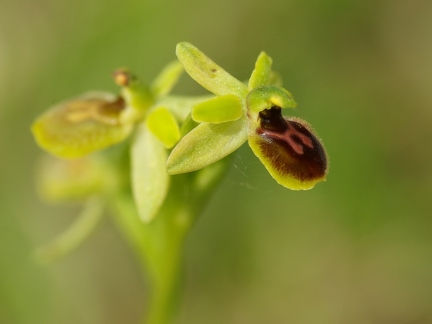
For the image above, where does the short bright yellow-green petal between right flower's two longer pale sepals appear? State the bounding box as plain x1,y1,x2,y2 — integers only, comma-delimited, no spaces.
192,94,243,124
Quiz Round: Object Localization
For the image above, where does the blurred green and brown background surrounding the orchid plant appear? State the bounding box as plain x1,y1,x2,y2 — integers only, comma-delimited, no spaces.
0,0,432,324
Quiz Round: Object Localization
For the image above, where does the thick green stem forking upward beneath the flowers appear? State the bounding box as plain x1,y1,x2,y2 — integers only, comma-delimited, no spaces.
111,161,227,324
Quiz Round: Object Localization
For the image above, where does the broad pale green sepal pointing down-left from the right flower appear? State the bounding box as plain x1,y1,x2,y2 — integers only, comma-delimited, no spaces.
167,117,248,174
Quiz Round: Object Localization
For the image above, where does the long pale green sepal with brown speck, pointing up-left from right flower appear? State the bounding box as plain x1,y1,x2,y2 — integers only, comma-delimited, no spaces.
176,42,248,98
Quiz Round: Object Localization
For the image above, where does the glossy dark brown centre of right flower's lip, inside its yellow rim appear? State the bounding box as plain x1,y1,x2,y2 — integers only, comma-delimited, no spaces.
256,107,327,182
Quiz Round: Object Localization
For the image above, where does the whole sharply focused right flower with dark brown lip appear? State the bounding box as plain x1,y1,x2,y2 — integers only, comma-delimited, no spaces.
167,42,327,190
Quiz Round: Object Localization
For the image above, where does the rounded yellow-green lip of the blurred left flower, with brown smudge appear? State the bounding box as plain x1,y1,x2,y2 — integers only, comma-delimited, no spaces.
32,92,132,158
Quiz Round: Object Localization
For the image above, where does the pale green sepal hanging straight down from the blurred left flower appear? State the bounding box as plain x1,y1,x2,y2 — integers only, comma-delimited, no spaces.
131,125,169,222
